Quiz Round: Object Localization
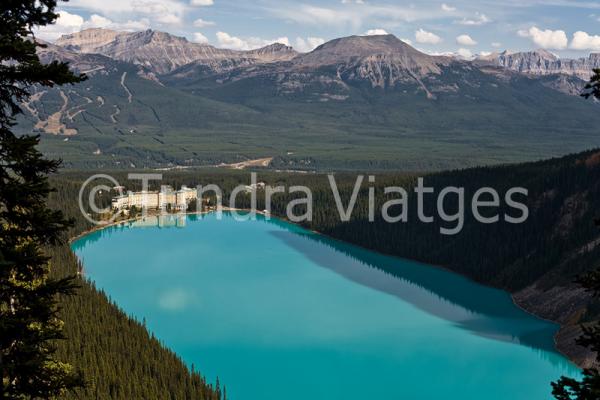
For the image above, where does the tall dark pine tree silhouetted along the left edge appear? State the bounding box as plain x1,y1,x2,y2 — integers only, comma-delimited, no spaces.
0,0,84,399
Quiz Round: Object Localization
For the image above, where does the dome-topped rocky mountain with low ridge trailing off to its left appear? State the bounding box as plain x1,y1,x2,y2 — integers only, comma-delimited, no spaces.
163,35,467,101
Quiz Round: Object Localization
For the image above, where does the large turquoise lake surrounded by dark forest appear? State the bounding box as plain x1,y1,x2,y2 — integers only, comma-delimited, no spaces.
73,214,579,400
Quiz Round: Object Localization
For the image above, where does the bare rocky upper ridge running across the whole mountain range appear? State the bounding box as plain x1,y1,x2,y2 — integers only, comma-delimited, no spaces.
54,29,600,100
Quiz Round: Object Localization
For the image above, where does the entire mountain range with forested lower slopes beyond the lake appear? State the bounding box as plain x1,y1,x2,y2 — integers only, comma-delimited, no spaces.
21,29,600,169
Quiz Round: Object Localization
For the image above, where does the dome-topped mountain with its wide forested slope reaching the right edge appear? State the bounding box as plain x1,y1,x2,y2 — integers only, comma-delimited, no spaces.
161,36,598,169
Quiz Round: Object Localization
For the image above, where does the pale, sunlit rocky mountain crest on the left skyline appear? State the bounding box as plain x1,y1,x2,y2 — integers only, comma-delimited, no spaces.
56,29,297,74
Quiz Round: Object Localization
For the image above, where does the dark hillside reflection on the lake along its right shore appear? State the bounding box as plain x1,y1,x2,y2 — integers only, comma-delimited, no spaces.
271,230,558,351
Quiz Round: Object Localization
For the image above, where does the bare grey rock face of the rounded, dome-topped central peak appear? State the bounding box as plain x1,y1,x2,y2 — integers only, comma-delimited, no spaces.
209,35,458,94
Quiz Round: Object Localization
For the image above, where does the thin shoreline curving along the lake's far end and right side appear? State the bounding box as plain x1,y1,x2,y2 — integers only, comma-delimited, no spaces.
68,206,584,368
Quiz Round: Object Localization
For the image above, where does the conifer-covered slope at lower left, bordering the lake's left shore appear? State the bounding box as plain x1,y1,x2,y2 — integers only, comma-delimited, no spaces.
49,186,225,400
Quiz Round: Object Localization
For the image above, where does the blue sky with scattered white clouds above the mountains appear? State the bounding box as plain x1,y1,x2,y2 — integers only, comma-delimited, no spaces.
40,0,600,57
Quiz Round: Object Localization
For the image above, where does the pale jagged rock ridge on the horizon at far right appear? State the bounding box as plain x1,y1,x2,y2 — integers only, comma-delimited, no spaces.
477,50,600,81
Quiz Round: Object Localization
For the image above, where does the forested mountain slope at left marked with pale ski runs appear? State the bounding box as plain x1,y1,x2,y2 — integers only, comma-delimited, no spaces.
22,45,298,168
